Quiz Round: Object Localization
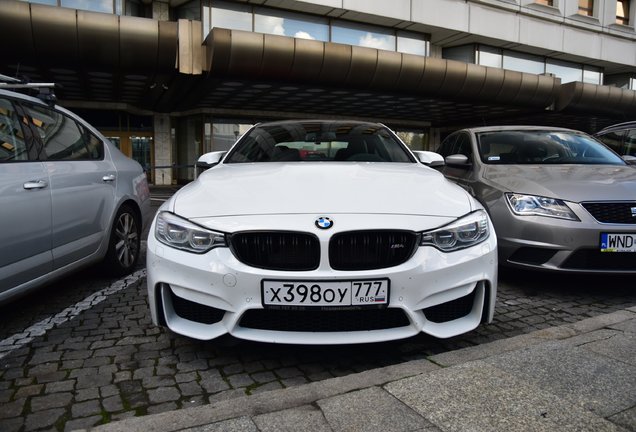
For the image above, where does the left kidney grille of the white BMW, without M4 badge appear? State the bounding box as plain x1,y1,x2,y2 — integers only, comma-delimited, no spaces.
230,231,320,271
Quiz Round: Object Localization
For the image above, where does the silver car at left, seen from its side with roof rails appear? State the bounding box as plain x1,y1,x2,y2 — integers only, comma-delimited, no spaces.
0,90,150,303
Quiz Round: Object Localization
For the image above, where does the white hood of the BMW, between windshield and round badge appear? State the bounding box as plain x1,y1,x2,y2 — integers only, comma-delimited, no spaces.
173,162,473,218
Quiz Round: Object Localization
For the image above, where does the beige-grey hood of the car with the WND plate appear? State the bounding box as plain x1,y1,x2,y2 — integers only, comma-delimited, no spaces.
483,165,636,202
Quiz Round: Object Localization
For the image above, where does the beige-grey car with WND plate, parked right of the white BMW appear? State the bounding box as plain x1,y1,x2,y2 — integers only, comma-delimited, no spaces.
438,126,636,273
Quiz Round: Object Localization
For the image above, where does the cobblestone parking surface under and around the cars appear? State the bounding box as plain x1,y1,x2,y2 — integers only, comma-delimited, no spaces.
0,192,636,432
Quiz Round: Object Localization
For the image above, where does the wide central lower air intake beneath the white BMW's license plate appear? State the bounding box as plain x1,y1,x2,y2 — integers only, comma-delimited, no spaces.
239,308,410,333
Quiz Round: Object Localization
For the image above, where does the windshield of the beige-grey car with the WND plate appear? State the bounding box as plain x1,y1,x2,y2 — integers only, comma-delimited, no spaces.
477,131,625,165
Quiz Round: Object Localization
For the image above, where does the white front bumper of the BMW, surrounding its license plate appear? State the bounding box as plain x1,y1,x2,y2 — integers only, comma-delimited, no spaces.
147,230,497,344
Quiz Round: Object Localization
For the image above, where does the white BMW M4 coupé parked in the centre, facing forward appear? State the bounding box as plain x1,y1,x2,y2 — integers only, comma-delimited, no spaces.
147,120,497,344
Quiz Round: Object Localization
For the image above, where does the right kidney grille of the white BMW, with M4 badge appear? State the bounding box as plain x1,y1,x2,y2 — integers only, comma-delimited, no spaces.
329,230,417,270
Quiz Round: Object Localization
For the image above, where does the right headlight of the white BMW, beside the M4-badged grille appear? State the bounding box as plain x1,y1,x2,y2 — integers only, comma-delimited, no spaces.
420,210,490,252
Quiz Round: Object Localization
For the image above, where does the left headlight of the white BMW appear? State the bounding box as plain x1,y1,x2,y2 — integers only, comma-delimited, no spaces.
155,212,227,253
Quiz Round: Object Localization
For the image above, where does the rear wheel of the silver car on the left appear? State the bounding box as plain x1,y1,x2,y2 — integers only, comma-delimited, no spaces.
104,204,141,276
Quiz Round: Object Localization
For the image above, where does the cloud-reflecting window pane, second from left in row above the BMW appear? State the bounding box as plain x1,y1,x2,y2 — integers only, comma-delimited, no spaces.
254,8,329,42
